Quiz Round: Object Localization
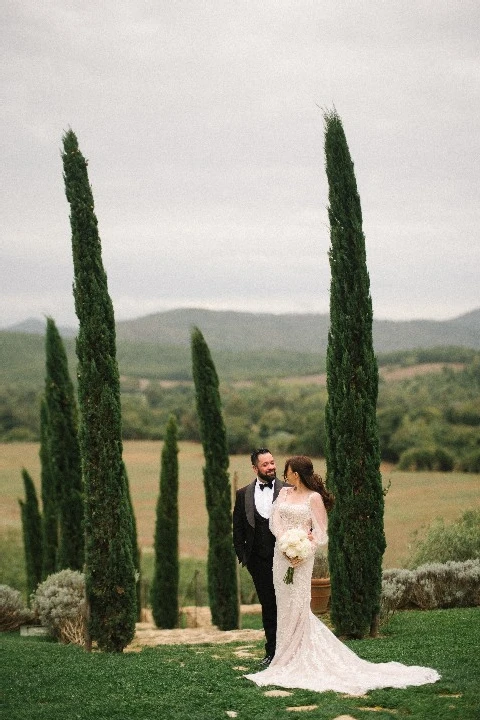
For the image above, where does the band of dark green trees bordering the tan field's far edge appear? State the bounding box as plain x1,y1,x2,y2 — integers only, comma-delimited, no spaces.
6,348,480,472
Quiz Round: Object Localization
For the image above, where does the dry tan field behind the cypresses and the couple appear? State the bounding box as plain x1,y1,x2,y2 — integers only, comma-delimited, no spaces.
0,441,480,567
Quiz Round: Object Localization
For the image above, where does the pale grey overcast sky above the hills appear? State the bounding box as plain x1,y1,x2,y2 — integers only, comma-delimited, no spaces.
0,0,480,327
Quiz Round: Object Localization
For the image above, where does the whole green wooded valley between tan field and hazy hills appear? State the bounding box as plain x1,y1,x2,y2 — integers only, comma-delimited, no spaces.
0,332,480,472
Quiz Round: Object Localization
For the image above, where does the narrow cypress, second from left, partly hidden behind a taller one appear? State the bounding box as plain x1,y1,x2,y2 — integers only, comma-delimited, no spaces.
40,398,58,580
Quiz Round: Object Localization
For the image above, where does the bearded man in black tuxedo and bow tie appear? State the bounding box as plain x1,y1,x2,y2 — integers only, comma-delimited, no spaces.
233,448,283,666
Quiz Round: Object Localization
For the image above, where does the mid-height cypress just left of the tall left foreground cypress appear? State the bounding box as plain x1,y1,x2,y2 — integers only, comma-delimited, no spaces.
44,318,85,570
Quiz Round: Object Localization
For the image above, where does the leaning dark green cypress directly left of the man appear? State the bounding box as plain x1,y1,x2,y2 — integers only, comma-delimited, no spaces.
192,328,239,630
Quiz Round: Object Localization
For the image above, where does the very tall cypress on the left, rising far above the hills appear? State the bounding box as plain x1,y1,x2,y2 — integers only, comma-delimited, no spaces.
62,130,137,652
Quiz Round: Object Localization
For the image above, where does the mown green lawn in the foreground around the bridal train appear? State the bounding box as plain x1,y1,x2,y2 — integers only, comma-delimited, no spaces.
0,608,480,720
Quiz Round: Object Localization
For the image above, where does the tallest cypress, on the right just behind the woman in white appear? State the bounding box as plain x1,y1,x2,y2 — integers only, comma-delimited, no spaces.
325,110,385,637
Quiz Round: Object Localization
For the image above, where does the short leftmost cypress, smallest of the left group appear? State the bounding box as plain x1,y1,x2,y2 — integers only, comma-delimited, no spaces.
18,468,42,598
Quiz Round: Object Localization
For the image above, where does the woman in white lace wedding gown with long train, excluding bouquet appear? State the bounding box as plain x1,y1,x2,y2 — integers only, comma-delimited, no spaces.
245,455,440,695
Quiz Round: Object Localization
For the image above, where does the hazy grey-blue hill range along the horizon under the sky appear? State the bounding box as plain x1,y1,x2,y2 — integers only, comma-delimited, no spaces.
3,308,480,355
